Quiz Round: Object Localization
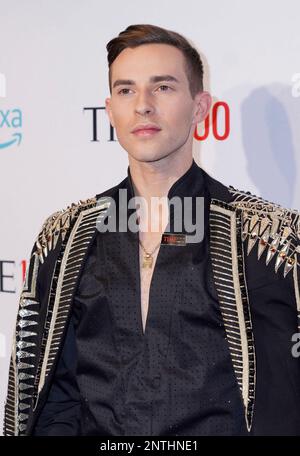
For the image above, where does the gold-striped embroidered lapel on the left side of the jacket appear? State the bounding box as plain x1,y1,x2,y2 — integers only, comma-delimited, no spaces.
26,197,110,434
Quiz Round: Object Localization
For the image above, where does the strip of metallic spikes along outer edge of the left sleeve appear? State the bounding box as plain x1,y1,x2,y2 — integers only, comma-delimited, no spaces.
3,213,59,436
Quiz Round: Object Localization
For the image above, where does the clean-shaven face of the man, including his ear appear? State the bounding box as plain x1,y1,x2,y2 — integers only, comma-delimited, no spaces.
105,44,210,162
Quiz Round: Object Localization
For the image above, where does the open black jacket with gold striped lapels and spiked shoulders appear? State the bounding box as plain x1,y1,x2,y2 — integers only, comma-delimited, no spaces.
4,162,300,435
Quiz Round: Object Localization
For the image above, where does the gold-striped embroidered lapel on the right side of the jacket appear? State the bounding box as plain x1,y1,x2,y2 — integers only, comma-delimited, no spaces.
209,198,255,431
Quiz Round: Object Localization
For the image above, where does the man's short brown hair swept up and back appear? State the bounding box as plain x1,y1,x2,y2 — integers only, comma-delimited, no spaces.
106,24,203,99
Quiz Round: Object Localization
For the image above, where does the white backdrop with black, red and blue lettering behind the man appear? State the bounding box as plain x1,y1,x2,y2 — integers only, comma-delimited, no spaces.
0,0,300,427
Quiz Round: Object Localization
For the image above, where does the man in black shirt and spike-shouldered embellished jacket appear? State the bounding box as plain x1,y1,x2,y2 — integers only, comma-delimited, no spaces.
4,24,300,435
